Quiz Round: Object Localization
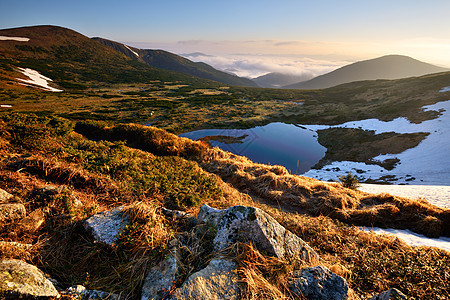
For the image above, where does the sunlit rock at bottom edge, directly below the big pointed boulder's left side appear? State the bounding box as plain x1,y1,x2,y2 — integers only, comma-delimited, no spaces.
172,259,239,300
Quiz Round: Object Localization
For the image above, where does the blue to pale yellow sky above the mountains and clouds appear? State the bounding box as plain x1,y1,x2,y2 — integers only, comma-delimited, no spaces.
0,0,450,77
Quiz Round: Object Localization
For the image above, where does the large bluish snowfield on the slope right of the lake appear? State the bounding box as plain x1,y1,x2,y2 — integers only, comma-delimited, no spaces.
303,100,450,185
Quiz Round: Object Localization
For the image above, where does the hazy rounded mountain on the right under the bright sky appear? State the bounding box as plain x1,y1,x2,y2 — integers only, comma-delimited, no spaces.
283,55,449,89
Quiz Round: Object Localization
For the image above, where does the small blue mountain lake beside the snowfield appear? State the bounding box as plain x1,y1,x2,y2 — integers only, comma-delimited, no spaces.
180,123,326,174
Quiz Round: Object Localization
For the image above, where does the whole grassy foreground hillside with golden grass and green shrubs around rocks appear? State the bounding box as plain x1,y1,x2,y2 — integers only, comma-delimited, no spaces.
0,114,450,299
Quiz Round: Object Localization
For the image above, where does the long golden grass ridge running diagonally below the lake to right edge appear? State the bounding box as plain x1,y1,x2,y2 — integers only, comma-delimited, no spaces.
72,123,450,237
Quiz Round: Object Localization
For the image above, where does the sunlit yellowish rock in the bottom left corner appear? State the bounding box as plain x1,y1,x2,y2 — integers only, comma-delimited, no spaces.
0,259,59,298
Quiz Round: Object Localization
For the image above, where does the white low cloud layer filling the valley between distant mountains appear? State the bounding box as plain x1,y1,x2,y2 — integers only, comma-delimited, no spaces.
182,52,349,78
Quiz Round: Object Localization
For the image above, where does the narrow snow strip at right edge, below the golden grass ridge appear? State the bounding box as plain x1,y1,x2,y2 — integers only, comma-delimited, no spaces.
360,227,450,251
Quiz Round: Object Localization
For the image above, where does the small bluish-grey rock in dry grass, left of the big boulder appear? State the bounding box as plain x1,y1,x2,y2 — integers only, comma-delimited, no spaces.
83,206,131,246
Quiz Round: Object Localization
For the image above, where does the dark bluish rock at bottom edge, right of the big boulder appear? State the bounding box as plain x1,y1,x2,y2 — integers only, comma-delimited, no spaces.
289,266,349,300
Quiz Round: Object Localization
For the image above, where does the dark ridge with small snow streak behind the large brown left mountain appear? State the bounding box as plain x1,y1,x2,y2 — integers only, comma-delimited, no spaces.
93,38,257,87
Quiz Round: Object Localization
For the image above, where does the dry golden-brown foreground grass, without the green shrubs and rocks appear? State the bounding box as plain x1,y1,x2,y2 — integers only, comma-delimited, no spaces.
0,116,450,299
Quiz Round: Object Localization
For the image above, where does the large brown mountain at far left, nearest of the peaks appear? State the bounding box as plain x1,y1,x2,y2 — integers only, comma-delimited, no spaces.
0,25,211,89
